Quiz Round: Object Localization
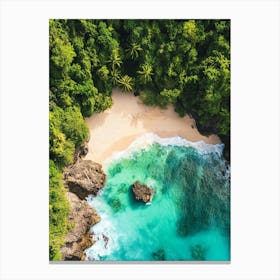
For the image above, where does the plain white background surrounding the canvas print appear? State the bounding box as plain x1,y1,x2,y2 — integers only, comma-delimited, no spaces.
0,0,280,280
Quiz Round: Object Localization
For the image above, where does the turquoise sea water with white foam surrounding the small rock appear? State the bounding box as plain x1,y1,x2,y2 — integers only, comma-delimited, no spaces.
86,134,230,261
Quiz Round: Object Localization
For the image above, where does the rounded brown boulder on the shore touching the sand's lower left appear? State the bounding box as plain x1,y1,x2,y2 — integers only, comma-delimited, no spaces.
64,160,106,199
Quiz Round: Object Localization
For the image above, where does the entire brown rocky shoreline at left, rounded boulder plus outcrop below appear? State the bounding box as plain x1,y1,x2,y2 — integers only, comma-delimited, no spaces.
60,157,106,261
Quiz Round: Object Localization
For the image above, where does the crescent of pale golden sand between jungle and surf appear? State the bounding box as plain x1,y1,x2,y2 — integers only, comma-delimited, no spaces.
85,89,221,164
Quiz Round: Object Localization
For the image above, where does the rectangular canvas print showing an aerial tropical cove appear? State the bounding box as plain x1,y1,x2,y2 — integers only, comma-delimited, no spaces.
49,19,230,262
